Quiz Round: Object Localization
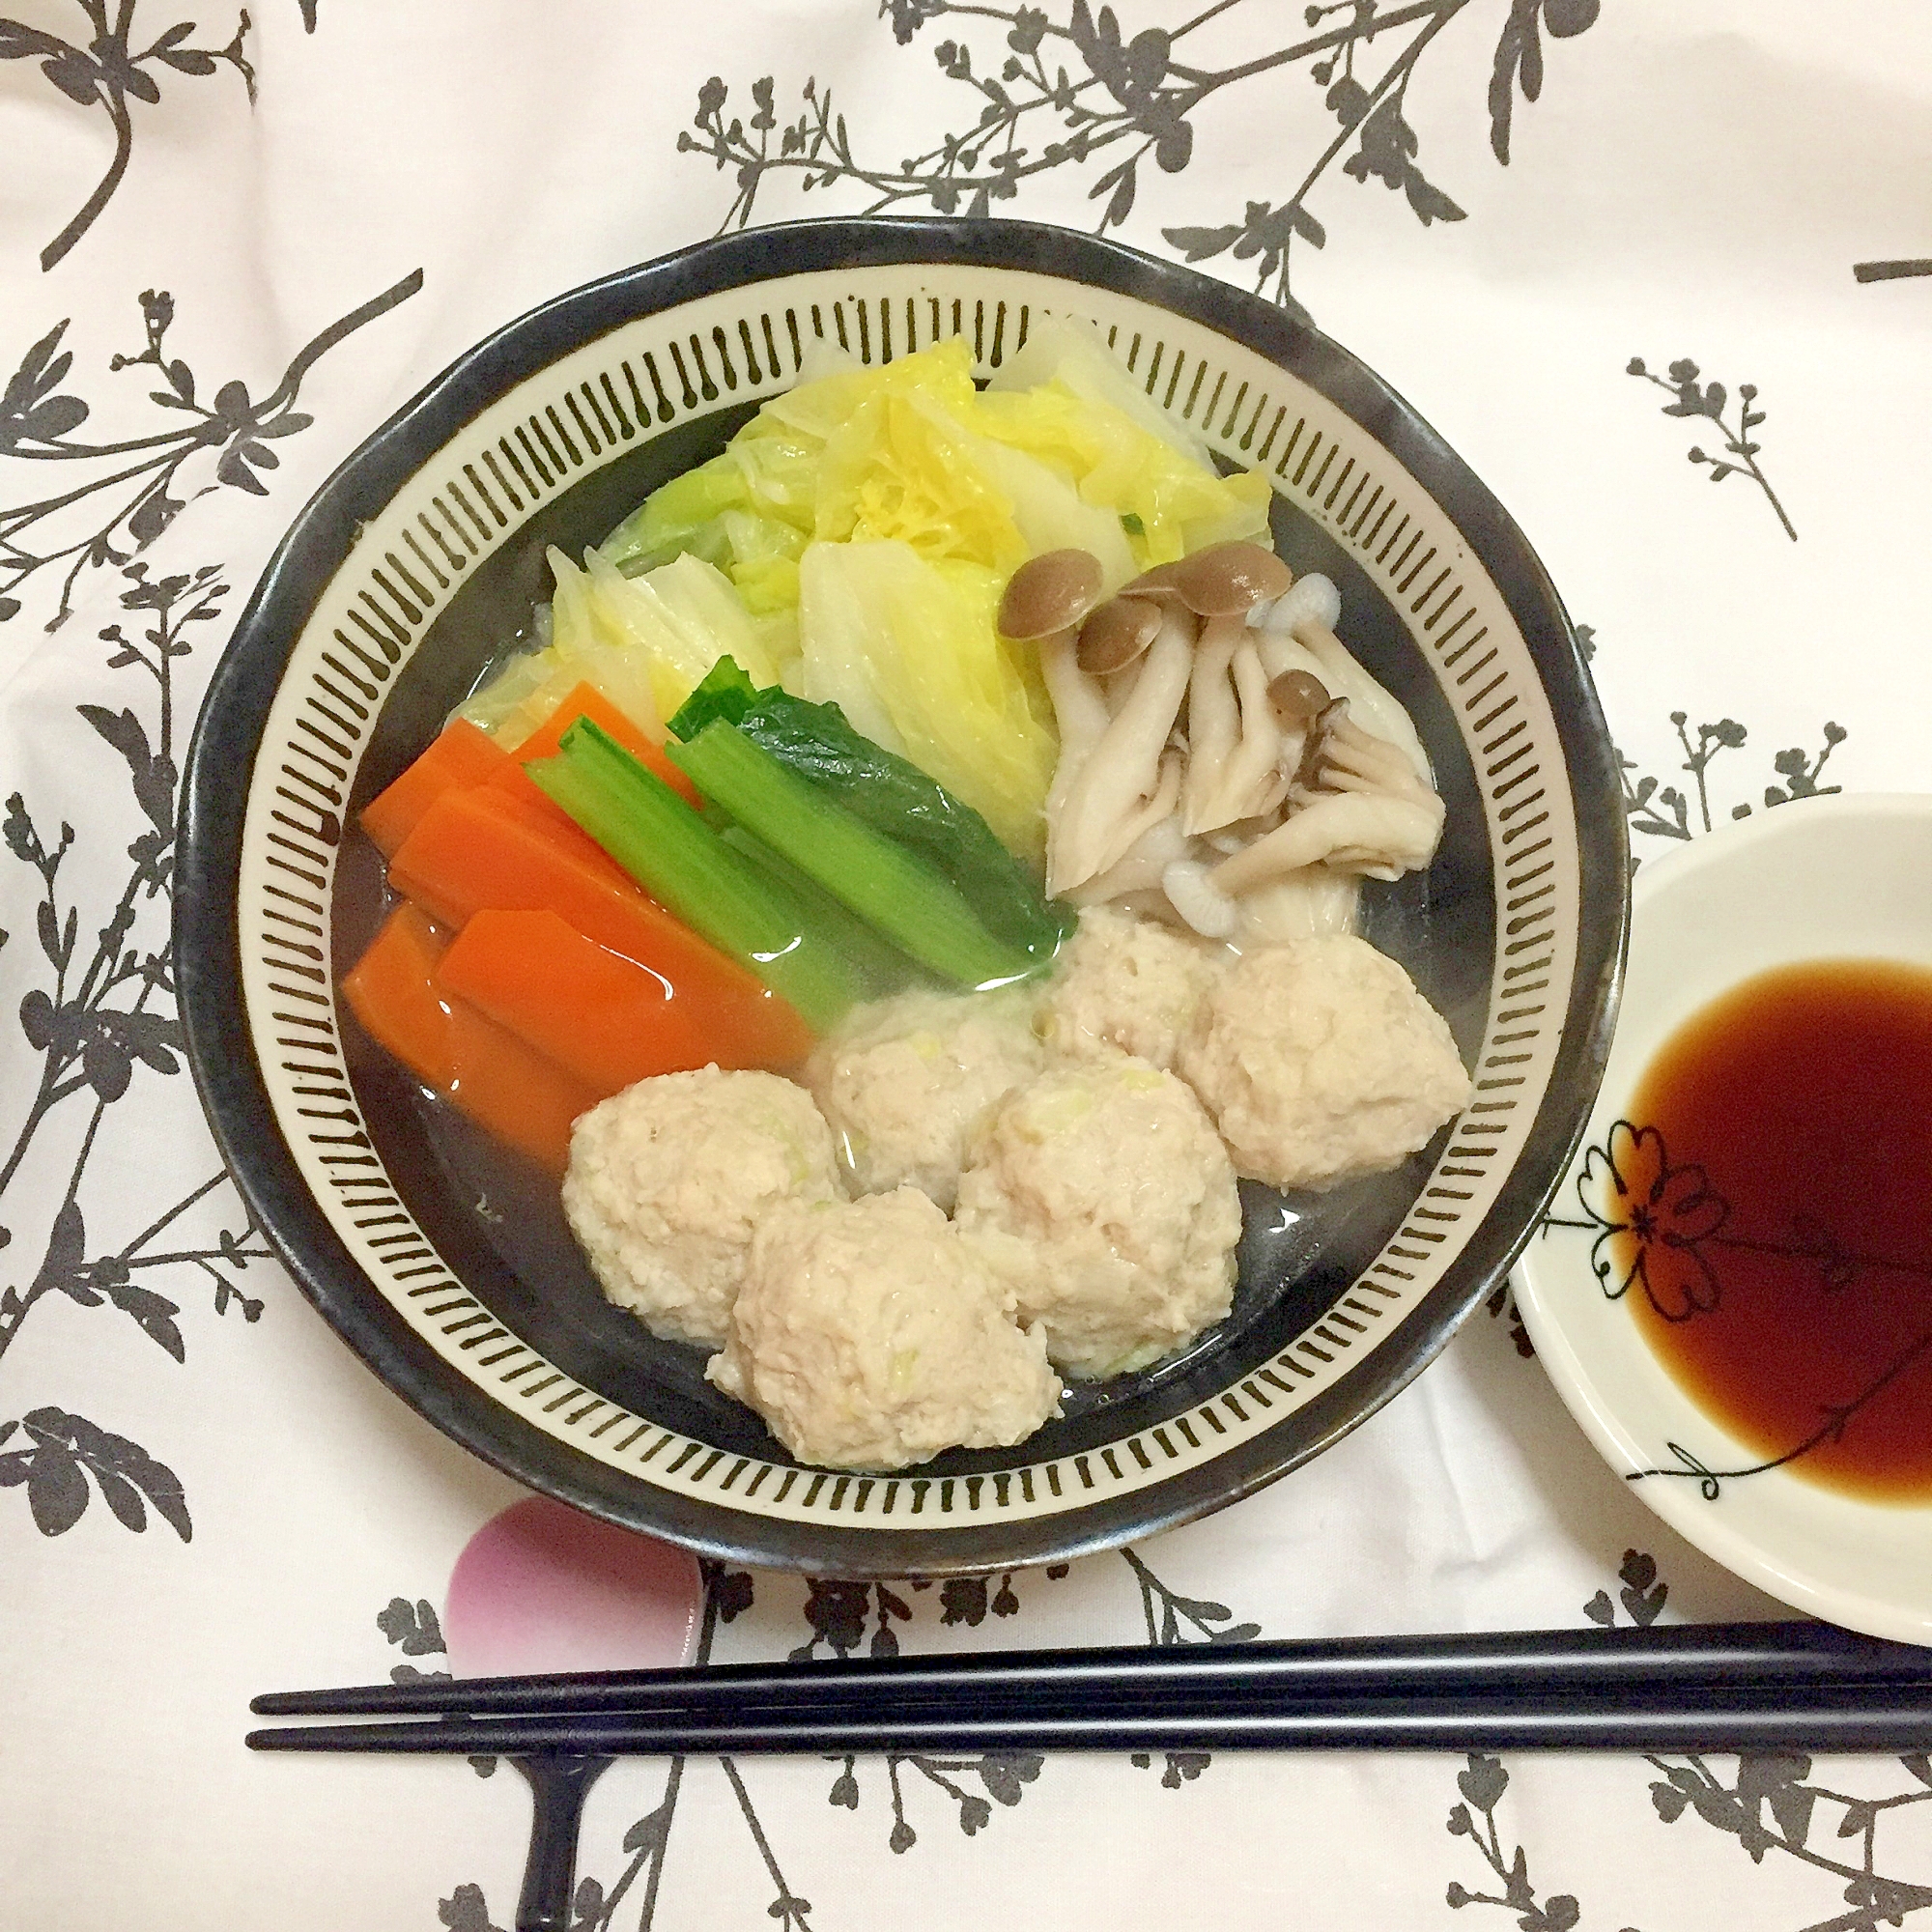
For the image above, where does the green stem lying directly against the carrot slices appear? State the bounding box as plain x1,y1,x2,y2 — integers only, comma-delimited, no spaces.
524,719,866,1032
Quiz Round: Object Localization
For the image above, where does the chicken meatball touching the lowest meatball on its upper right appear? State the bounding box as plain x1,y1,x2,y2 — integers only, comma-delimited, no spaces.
958,1053,1240,1376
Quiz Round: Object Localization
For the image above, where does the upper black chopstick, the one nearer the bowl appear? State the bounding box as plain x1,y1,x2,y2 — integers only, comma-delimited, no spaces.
249,1623,1932,1721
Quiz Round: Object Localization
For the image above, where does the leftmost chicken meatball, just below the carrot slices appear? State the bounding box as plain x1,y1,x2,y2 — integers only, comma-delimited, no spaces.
564,1066,838,1349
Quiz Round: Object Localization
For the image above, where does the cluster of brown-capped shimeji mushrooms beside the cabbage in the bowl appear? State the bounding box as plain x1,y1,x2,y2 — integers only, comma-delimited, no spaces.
1001,543,1443,916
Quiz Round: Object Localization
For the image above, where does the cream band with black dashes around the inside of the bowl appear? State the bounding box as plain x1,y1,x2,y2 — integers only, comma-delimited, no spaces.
238,265,1580,1530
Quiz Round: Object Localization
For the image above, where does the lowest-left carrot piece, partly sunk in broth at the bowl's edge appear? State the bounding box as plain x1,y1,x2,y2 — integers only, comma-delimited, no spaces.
342,906,603,1175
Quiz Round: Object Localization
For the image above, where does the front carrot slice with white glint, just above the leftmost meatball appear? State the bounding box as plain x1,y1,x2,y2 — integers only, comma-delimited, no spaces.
442,912,811,1094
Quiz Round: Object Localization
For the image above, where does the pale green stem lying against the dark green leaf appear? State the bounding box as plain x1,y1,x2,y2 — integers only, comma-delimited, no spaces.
665,721,1039,985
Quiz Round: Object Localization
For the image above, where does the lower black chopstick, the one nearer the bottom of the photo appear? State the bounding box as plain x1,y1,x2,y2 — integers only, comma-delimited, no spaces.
247,1685,1932,1758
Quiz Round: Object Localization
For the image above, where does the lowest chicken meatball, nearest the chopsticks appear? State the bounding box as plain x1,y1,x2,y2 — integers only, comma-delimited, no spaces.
705,1188,1061,1468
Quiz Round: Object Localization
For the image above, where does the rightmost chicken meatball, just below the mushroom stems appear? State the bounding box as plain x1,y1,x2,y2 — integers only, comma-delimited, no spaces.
1179,935,1470,1188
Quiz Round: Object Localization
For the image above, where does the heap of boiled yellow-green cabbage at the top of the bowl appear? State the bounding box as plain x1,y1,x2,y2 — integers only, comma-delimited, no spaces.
558,332,1271,854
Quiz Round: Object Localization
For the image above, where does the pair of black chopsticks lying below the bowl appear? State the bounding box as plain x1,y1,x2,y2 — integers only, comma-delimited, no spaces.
247,1623,1932,1758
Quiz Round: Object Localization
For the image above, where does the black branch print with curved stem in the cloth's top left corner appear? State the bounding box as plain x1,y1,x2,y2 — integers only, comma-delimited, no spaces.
0,0,255,270
